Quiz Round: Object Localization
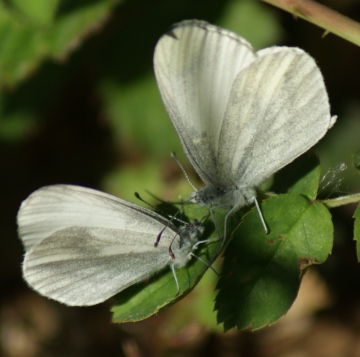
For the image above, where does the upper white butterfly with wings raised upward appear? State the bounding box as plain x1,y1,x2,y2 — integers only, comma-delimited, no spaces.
154,20,336,237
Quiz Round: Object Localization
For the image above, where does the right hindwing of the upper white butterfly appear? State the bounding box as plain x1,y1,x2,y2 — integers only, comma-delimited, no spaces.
217,47,336,187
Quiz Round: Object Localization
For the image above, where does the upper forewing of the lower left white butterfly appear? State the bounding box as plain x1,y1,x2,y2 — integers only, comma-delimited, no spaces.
17,185,172,251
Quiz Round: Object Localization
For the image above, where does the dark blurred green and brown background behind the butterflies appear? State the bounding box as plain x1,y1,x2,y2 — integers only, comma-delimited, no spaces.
0,0,360,357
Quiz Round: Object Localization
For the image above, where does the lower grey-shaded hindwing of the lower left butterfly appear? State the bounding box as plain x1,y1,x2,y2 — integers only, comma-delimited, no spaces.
23,227,170,306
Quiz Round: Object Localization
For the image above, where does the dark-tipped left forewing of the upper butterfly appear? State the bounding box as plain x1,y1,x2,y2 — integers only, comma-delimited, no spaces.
154,20,255,186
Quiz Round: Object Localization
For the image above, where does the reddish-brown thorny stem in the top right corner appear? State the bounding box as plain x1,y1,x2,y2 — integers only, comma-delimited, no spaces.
262,0,360,46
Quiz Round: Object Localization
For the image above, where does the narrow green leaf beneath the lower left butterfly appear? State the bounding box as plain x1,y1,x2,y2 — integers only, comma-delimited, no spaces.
112,205,223,323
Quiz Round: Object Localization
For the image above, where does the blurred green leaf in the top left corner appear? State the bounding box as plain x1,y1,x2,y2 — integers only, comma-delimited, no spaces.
0,0,120,86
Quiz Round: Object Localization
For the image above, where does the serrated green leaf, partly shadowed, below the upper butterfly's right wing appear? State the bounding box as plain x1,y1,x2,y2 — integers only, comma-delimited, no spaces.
215,194,333,330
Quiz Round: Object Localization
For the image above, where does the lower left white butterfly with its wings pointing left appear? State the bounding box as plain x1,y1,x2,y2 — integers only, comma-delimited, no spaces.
17,185,203,306
